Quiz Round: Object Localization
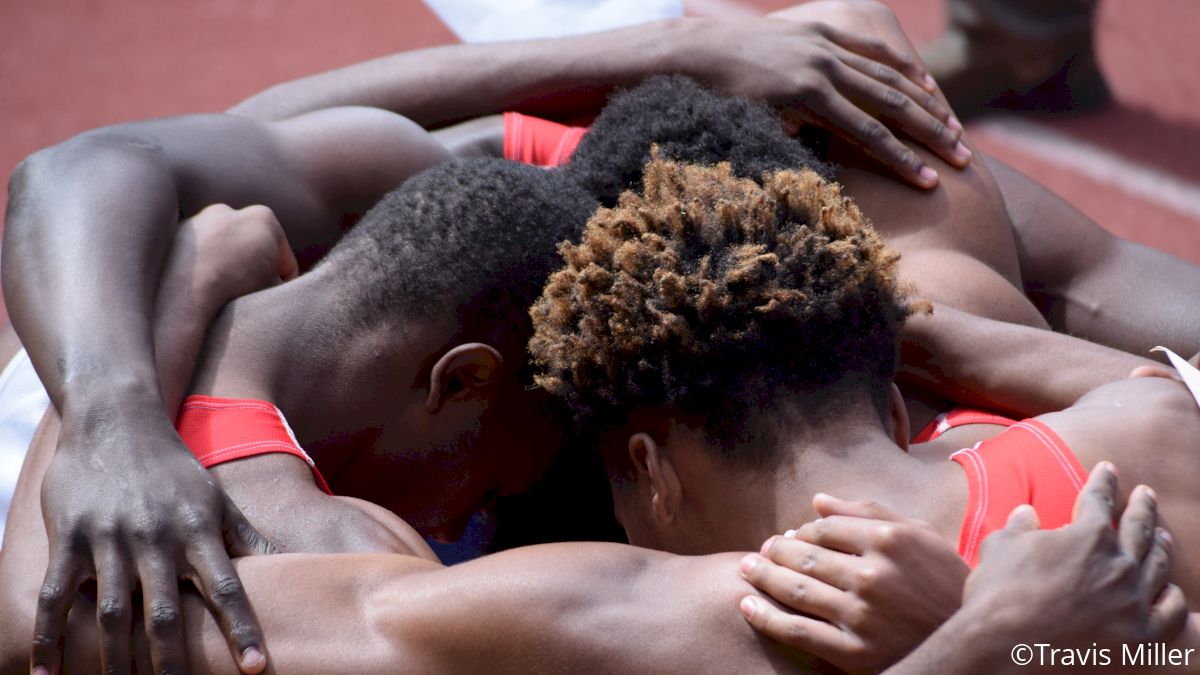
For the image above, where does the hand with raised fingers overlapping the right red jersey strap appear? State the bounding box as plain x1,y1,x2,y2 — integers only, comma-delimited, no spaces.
962,462,1188,647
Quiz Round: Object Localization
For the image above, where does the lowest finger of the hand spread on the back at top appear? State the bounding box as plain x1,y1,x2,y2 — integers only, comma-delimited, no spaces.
806,92,937,190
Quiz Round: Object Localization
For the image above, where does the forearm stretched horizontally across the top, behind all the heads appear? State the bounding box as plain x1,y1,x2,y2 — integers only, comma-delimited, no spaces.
229,18,709,123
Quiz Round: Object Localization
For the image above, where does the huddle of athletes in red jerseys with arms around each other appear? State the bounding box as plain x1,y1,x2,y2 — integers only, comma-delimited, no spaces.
0,2,1200,673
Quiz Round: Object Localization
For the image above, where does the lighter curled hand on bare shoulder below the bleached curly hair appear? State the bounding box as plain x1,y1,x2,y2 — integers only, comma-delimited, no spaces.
742,495,968,673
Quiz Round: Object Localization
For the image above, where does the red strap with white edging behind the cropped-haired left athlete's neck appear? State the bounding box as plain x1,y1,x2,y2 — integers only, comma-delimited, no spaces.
175,396,334,495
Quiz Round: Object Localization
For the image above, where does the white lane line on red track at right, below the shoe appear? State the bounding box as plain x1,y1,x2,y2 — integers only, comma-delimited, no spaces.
970,117,1200,219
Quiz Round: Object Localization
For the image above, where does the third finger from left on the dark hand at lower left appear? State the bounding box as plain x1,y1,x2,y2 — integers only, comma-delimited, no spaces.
138,551,188,674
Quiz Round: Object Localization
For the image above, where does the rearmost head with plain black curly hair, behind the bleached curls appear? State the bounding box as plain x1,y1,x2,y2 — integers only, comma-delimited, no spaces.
565,76,830,207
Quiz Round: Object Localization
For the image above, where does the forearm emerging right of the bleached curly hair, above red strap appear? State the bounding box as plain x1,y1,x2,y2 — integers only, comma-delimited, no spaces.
900,305,1157,417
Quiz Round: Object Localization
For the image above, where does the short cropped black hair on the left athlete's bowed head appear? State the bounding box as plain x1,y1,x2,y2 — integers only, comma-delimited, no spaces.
322,159,596,357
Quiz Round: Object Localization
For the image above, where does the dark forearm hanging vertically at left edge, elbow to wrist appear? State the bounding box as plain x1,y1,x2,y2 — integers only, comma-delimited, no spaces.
2,138,179,418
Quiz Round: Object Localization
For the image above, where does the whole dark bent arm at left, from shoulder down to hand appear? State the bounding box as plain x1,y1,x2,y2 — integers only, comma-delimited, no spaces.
2,109,446,672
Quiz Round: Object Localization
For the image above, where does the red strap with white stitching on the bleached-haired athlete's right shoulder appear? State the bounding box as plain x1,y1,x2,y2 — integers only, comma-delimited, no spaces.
950,419,1087,568
